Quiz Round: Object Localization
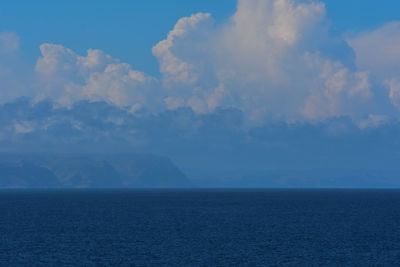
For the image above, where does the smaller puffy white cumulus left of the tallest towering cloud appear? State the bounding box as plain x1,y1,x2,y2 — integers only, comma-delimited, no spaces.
35,44,157,108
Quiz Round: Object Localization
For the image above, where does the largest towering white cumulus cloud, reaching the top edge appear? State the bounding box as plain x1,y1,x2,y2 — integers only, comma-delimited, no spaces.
153,0,373,120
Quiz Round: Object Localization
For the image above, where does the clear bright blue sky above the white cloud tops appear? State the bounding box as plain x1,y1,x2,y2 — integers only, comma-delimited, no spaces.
0,0,400,76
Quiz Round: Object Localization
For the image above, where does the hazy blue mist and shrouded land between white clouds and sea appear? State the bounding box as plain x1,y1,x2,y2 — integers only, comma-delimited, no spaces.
0,98,400,187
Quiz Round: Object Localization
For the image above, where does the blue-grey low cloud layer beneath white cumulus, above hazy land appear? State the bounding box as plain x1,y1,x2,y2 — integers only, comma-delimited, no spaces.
0,99,400,174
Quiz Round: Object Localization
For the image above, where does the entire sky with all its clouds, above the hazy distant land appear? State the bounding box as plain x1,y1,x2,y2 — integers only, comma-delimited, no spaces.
0,0,400,187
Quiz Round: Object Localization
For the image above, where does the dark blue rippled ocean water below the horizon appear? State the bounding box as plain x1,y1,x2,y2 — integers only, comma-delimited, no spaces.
0,190,400,266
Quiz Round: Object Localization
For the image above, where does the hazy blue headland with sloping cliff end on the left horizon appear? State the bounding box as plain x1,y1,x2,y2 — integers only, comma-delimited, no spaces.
0,154,190,188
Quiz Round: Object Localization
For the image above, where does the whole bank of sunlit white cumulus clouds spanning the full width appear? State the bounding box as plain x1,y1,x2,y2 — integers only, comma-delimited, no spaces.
0,0,400,125
